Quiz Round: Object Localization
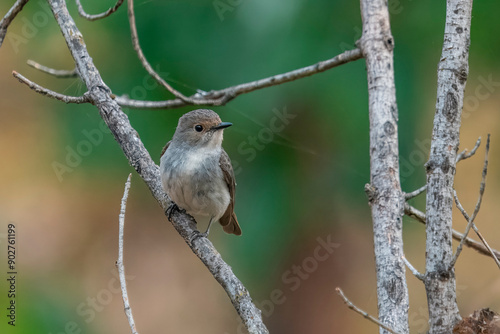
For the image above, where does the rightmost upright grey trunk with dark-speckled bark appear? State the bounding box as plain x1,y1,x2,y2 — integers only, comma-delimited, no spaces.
425,0,472,334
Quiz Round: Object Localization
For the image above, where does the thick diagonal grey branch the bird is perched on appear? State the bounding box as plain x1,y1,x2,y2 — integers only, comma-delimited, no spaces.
48,0,268,333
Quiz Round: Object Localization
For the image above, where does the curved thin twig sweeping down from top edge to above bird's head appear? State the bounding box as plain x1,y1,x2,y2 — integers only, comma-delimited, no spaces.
127,0,229,105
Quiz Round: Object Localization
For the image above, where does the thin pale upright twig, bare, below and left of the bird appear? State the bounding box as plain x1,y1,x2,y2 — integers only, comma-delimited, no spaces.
116,173,137,334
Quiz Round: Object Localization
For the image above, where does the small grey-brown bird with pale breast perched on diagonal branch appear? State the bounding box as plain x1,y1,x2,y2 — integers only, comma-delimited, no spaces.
160,109,241,236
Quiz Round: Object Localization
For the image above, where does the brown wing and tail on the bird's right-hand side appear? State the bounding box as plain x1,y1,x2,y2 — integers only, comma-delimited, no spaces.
219,149,241,235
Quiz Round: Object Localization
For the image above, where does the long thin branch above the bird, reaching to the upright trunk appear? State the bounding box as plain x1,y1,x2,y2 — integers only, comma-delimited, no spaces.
116,49,363,109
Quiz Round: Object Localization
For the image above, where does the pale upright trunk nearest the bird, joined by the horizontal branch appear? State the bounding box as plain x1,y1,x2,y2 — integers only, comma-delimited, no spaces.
358,0,409,333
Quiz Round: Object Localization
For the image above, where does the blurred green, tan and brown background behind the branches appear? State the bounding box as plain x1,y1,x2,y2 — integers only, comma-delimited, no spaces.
0,0,500,334
